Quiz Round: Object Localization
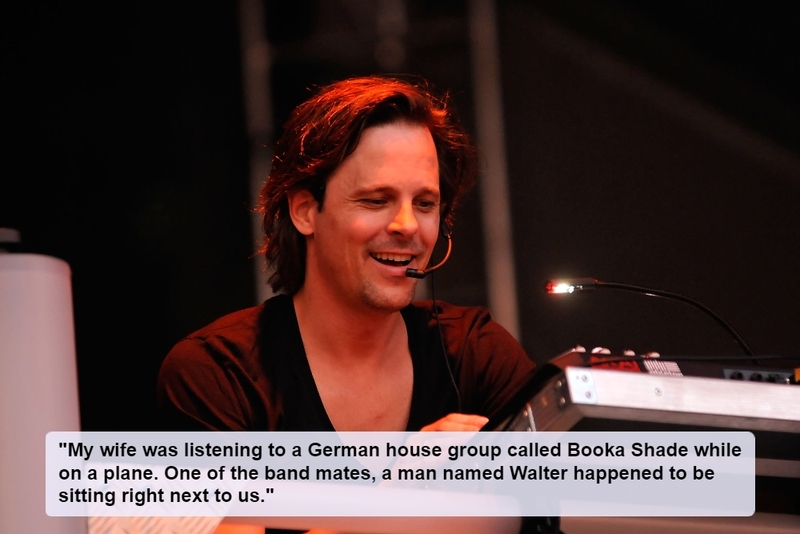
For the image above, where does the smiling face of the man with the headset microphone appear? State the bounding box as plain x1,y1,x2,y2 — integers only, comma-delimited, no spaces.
306,123,440,311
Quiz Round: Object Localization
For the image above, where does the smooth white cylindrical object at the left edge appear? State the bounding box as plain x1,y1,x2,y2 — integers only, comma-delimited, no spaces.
0,253,87,534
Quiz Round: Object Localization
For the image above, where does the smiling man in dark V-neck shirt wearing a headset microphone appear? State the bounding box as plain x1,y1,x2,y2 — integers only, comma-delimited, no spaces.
158,77,533,436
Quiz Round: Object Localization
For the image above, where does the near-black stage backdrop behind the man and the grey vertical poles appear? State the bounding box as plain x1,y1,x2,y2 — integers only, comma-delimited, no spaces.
0,0,800,430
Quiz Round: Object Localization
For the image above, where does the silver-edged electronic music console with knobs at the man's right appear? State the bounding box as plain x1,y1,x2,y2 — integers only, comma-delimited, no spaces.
486,347,800,514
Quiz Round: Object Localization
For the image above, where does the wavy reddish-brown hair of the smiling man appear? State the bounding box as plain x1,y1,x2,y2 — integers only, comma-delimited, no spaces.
259,76,477,295
